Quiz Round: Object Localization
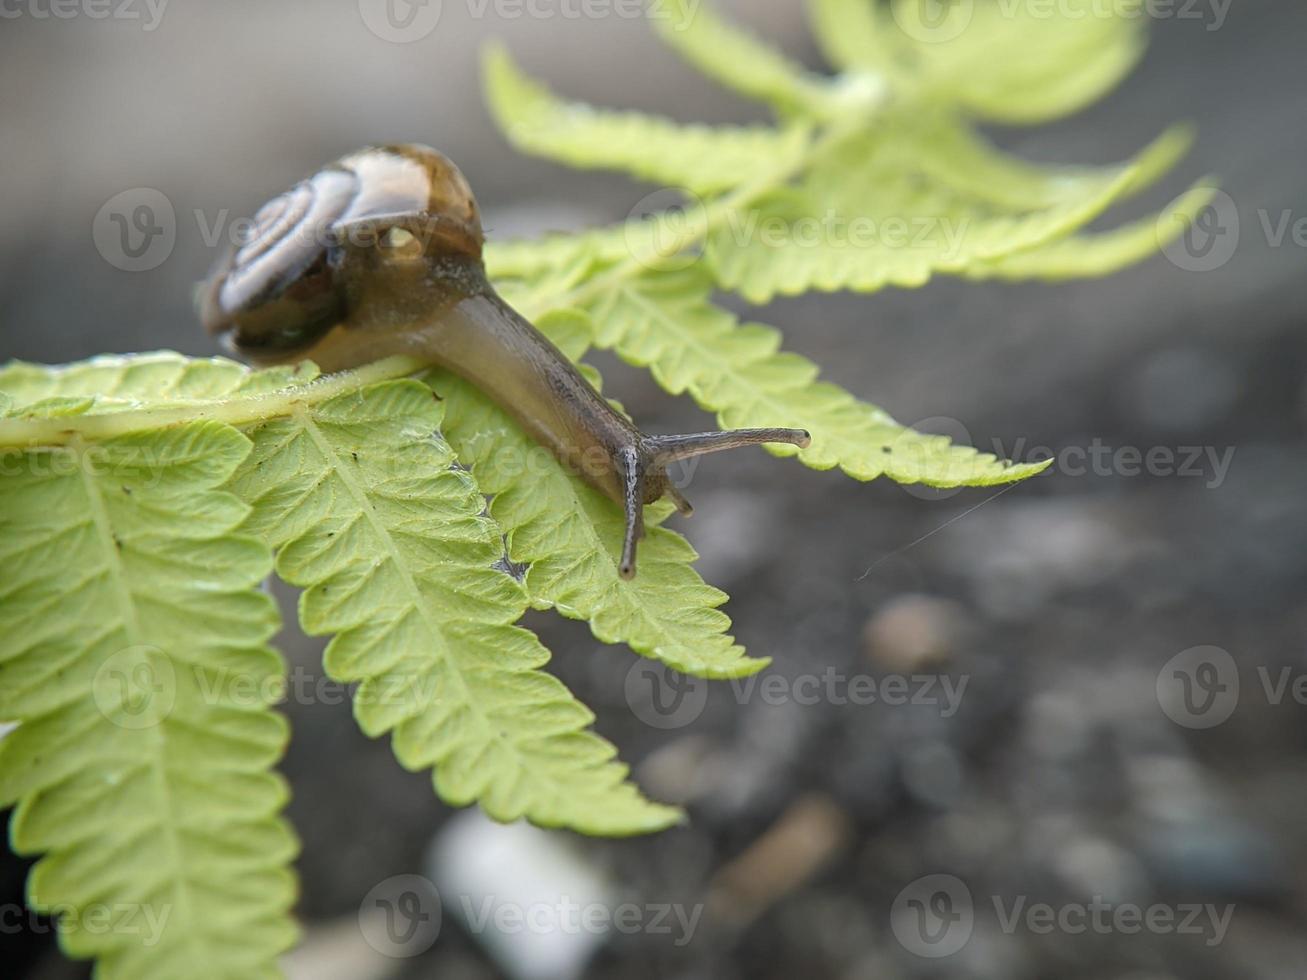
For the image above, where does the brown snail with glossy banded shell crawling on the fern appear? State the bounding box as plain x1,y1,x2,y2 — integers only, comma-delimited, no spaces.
199,145,809,579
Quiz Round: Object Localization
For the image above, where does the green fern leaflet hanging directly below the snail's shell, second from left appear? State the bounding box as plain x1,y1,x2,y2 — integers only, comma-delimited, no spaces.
233,382,680,835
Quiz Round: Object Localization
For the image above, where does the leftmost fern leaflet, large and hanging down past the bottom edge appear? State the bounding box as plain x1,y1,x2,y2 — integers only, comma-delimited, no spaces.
0,423,297,980
